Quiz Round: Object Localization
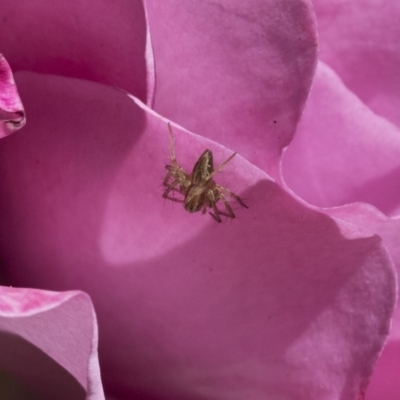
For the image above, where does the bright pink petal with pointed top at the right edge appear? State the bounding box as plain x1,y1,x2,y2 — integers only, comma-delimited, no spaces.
283,63,400,215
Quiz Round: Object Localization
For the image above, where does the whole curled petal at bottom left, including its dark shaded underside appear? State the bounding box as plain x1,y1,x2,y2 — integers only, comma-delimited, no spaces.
0,286,104,400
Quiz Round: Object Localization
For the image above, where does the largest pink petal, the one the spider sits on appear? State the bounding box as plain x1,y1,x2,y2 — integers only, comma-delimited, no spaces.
0,74,395,400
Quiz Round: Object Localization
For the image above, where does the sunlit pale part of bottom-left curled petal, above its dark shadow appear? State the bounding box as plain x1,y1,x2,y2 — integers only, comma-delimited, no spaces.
0,286,105,400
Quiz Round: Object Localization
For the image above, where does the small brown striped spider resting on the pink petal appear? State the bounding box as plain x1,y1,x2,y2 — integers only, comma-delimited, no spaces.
163,123,249,222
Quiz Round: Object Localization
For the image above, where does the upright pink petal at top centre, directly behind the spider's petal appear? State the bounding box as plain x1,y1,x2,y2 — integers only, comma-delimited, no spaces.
146,0,317,176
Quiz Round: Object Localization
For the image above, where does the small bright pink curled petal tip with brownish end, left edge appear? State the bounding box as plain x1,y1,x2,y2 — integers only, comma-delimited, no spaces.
0,54,25,138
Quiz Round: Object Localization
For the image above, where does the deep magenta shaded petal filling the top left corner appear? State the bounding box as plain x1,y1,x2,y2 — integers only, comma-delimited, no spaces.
0,0,154,101
